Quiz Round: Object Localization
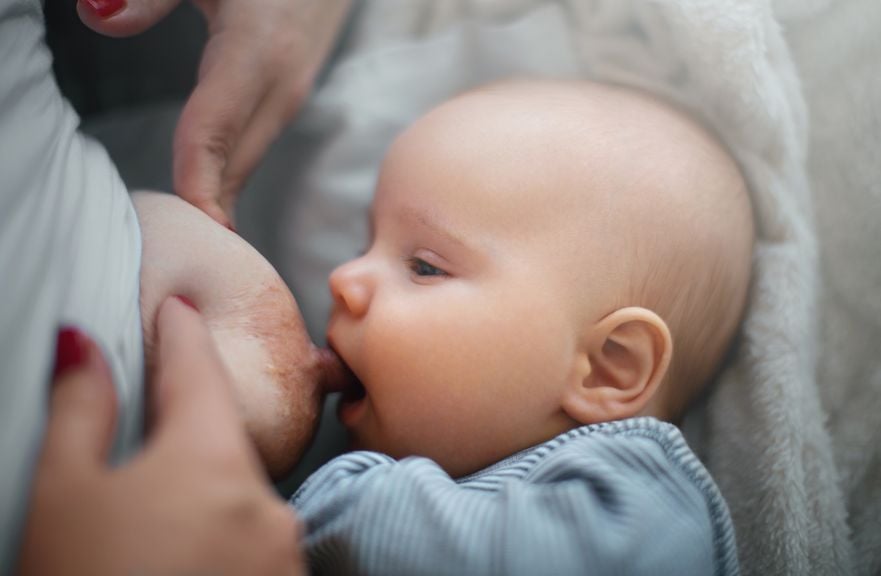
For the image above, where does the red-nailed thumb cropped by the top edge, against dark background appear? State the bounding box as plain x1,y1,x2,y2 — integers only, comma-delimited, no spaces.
76,0,180,37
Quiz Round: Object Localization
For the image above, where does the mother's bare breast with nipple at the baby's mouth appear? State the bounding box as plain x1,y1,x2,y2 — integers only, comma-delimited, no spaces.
133,192,341,477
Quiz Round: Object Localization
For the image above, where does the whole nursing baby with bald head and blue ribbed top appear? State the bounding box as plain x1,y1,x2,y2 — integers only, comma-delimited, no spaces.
292,81,753,574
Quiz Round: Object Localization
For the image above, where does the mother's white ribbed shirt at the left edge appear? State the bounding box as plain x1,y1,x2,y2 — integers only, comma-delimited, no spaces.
0,0,143,574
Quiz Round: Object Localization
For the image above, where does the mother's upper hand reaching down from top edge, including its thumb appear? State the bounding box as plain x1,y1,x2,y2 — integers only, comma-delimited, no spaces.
77,0,351,226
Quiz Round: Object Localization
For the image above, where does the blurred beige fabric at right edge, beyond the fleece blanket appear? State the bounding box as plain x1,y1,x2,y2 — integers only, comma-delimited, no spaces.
781,0,881,575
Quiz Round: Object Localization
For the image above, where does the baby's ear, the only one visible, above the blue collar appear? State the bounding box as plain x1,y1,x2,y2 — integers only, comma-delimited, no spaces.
562,307,673,424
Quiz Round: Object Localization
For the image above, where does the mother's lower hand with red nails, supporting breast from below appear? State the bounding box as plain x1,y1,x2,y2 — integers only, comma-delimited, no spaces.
20,298,302,575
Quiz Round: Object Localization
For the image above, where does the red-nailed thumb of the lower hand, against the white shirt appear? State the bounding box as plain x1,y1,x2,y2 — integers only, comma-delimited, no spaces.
43,328,116,474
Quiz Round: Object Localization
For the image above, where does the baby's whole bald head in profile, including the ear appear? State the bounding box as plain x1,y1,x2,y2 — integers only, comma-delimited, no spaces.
328,82,753,475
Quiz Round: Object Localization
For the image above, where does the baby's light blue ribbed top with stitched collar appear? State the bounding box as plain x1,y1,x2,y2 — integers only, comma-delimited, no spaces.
291,418,739,576
